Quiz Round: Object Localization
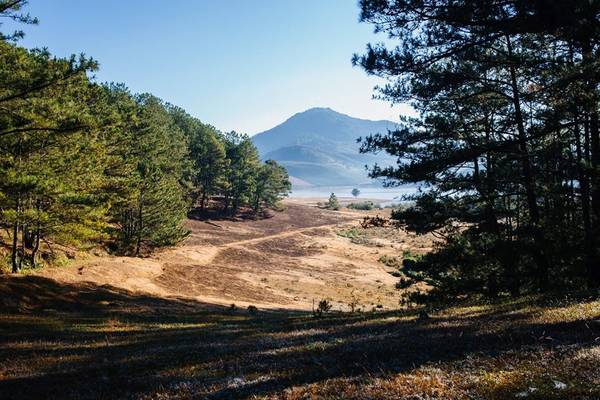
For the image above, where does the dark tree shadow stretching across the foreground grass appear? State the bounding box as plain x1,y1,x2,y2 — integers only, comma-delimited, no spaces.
0,276,600,399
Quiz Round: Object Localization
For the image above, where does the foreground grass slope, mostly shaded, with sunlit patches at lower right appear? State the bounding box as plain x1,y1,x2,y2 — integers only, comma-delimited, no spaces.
0,277,600,399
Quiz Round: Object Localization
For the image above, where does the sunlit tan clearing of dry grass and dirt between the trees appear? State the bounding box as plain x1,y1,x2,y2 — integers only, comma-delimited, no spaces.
41,201,428,310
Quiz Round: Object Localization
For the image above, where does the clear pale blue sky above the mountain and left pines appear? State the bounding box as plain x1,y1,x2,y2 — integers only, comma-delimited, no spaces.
10,0,406,134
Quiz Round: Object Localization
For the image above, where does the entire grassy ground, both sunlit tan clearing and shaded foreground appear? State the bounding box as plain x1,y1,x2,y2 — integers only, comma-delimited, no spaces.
0,204,600,399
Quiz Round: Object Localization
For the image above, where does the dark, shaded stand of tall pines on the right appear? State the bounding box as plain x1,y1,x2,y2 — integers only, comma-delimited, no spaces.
354,0,600,298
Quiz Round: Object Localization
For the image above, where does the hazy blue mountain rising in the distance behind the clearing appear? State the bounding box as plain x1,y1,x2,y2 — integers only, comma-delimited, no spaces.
252,108,397,186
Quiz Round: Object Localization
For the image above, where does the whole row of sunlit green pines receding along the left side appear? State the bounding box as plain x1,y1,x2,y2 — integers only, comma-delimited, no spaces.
0,1,290,272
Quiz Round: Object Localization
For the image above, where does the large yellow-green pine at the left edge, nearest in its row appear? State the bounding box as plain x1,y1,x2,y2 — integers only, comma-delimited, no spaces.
0,42,105,272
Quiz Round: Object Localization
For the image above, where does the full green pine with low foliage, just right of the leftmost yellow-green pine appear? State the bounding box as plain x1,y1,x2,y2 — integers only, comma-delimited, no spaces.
111,95,188,255
